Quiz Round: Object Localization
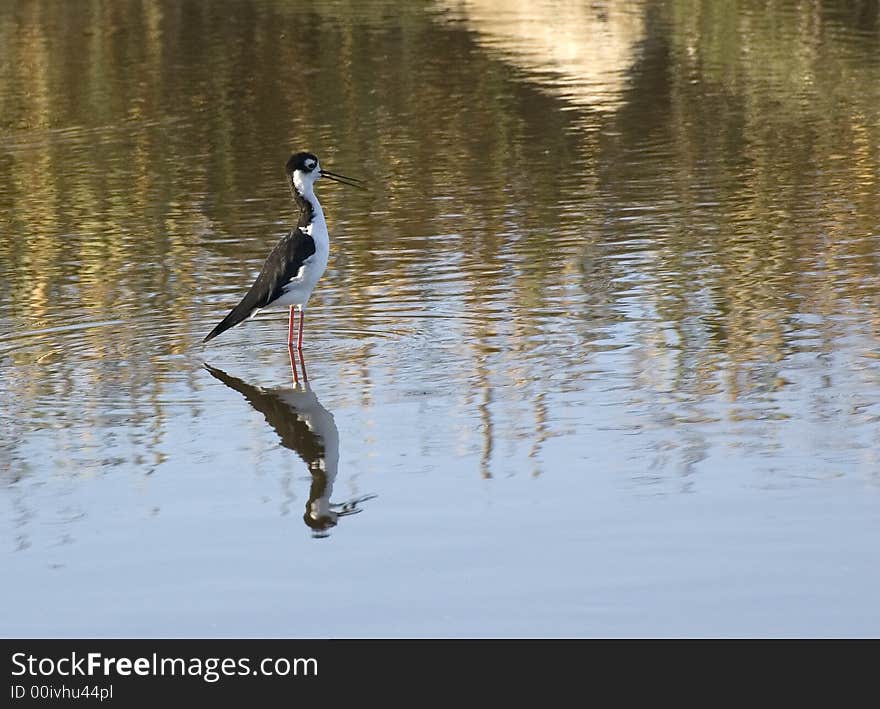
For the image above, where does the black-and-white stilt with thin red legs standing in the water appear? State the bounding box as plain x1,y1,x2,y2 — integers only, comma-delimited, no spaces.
204,153,361,349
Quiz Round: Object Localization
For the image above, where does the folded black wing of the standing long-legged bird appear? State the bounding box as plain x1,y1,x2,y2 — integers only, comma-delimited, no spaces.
204,228,315,342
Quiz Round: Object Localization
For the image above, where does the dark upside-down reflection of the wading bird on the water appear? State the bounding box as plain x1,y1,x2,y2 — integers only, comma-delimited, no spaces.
205,363,375,537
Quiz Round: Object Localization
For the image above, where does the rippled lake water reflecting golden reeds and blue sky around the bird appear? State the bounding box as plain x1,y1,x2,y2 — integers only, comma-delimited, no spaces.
0,0,880,637
